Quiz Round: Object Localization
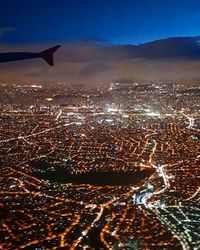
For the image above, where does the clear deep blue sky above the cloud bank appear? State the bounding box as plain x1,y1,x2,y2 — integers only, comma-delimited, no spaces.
0,0,200,44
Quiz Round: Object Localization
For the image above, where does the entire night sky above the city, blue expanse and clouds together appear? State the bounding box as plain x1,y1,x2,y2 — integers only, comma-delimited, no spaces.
0,0,200,83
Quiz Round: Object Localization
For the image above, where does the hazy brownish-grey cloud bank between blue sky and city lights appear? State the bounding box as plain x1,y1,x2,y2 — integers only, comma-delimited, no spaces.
0,37,200,84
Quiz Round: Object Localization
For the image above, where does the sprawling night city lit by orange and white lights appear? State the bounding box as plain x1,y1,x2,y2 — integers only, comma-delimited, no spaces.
0,80,200,250
